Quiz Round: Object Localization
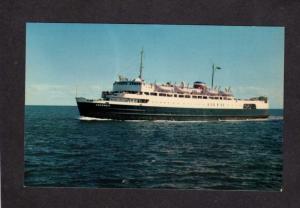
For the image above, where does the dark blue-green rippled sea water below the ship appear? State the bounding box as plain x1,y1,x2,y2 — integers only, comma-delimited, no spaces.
25,106,283,191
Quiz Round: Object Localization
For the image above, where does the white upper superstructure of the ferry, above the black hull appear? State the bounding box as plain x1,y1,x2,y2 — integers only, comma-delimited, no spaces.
98,79,269,109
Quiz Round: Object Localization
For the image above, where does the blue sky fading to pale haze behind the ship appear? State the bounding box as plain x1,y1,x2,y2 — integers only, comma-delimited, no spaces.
25,23,284,108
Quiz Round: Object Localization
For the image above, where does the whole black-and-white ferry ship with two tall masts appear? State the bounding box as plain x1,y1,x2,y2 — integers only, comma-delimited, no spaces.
76,50,269,121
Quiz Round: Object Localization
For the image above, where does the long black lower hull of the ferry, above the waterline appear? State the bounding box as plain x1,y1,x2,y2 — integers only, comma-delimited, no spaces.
77,102,269,121
